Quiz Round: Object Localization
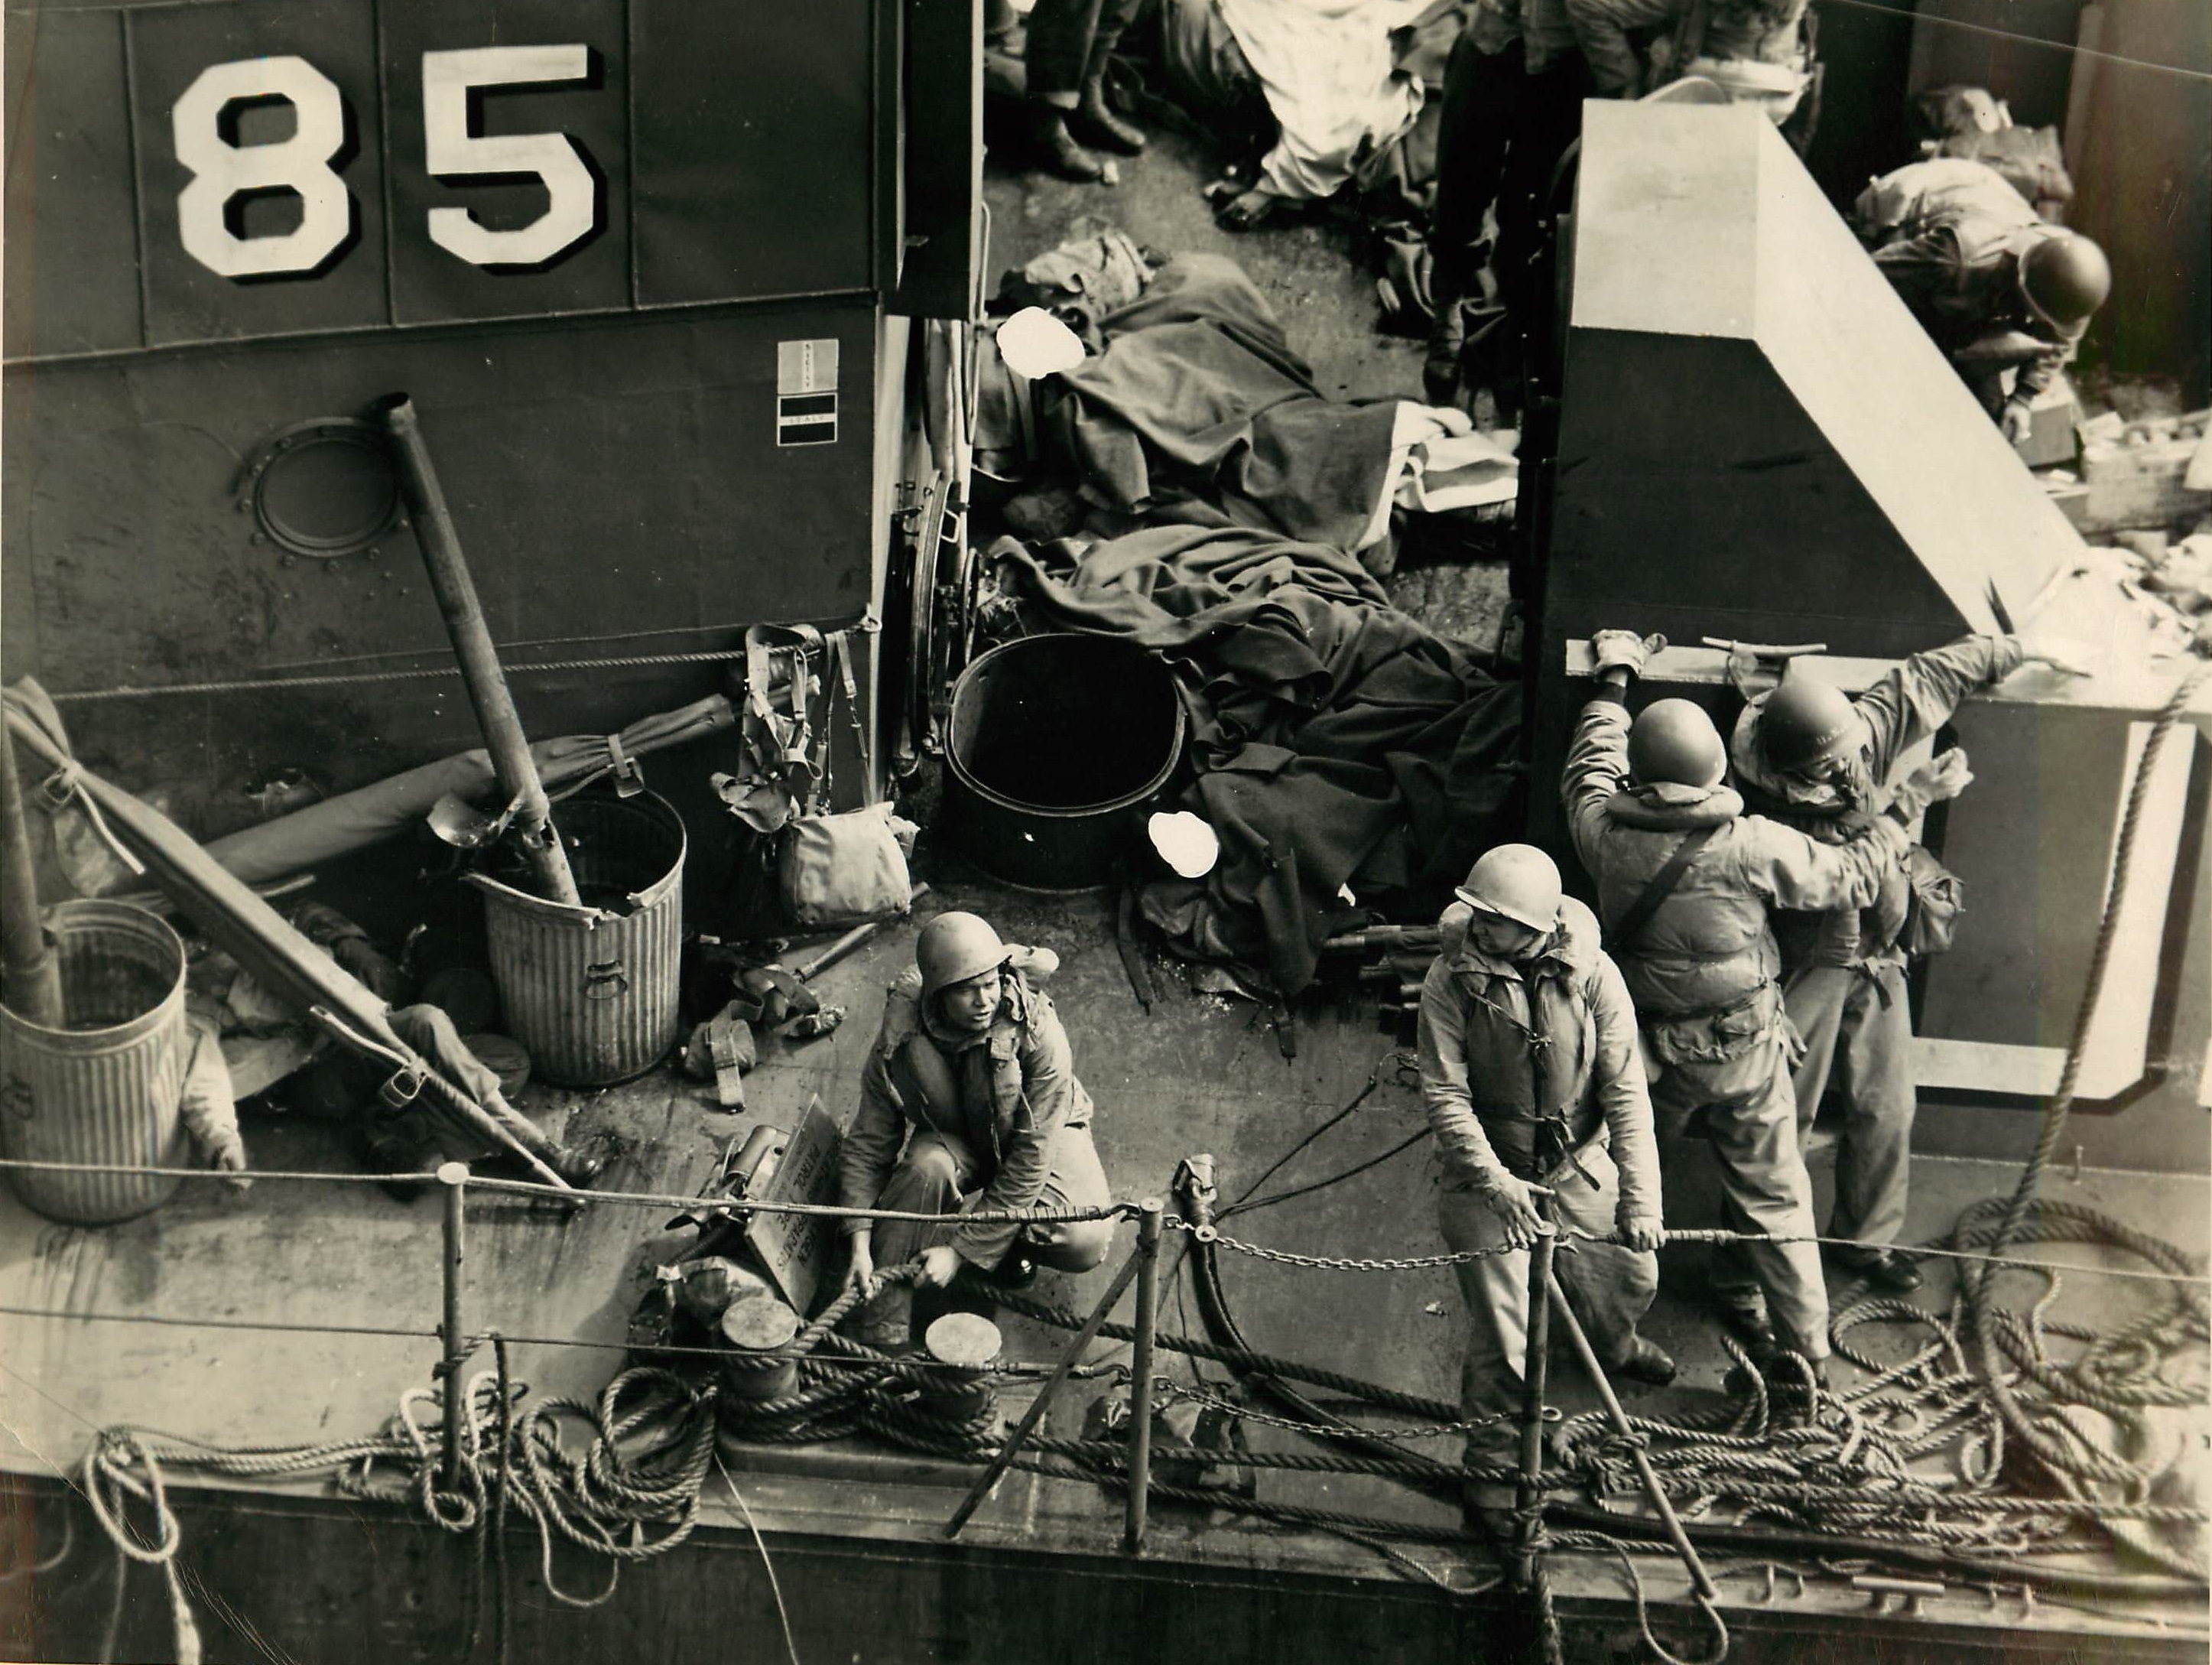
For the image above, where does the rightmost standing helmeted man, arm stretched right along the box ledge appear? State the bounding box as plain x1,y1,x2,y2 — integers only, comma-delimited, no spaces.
1730,637,2071,1293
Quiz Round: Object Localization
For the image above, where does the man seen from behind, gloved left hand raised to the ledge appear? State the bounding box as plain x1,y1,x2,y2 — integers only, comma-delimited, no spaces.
1561,630,1905,1382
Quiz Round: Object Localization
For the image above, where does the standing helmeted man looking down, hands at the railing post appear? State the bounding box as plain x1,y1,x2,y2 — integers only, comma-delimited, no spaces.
1420,844,1674,1524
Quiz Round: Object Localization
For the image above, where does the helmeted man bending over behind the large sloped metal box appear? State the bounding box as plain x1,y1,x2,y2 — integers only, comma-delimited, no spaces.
1853,157,2113,444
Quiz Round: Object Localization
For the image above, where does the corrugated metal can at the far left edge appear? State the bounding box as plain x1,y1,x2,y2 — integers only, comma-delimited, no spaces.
0,902,190,1225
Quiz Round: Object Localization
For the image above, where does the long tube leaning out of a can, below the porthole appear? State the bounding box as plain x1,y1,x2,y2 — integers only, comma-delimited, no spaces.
382,394,582,906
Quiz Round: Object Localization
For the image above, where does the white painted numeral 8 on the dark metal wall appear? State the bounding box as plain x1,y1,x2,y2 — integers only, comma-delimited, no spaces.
171,57,354,278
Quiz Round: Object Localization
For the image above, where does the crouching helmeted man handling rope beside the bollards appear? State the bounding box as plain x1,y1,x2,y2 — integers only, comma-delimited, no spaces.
840,913,1112,1349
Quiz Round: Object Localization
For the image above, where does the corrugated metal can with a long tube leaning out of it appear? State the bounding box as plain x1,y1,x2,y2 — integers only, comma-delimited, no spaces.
469,792,686,1088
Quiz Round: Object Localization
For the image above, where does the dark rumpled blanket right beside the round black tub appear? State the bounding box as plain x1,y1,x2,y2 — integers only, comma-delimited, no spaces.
993,526,1519,995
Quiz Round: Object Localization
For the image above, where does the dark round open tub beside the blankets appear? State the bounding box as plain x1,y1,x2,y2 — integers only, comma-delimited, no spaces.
944,635,1184,891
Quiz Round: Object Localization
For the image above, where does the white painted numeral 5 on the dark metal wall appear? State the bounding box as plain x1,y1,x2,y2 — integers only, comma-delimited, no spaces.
423,47,599,265
